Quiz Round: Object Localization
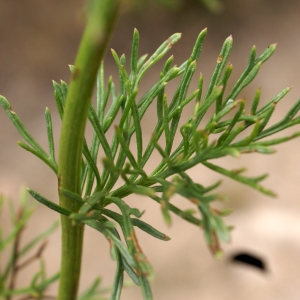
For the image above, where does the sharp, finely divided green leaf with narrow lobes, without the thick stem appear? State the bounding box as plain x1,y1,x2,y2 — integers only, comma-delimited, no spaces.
0,29,300,299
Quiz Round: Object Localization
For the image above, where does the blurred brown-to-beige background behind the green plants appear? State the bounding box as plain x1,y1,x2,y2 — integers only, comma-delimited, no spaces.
0,0,300,300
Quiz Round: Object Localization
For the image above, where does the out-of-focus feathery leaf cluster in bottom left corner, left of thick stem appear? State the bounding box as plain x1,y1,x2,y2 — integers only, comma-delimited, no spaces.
0,190,59,300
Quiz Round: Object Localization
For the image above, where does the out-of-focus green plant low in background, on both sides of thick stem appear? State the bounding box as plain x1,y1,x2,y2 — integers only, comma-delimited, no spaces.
0,189,110,300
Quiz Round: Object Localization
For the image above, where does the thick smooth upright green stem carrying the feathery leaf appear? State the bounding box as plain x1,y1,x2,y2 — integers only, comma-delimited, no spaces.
58,0,119,300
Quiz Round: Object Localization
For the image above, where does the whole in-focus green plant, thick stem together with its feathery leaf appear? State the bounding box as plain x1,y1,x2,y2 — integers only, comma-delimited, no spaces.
0,0,300,299
